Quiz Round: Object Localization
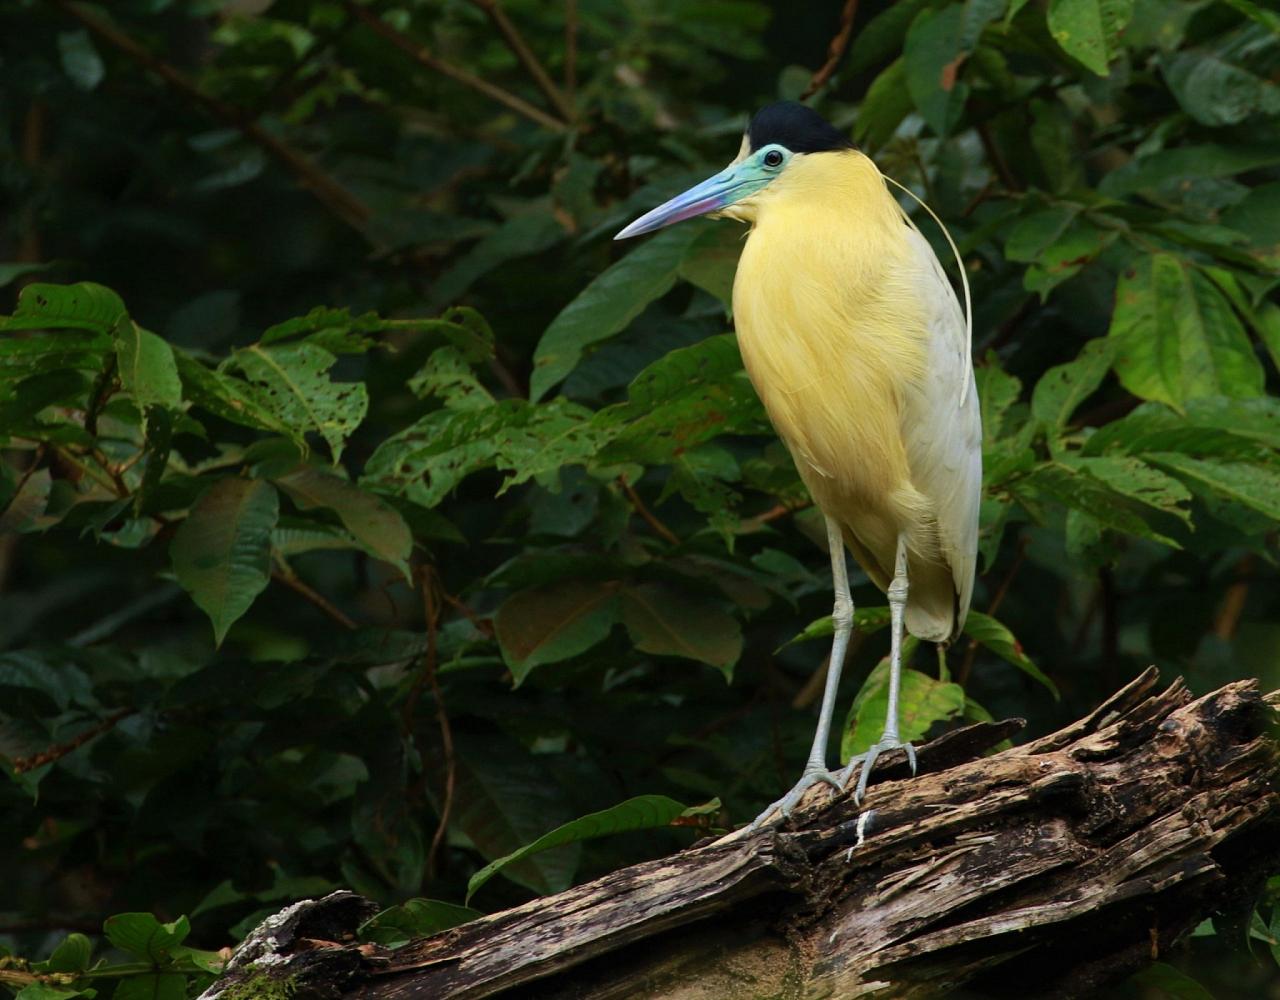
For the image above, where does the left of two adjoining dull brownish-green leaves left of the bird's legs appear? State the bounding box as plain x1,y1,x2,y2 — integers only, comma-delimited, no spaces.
494,580,618,685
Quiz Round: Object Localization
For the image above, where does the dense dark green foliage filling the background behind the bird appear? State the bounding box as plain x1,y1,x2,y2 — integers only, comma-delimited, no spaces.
0,0,1280,1000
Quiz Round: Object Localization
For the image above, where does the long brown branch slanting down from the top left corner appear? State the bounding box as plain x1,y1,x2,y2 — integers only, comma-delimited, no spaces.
50,0,371,239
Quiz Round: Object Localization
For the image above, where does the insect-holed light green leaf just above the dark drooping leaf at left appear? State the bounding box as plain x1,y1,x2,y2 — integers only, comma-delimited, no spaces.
236,342,369,462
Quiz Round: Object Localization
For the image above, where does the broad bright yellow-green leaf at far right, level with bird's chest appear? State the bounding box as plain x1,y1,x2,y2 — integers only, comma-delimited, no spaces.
1107,254,1265,408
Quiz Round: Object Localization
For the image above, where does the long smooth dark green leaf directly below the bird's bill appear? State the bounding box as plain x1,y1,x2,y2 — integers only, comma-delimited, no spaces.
529,224,703,402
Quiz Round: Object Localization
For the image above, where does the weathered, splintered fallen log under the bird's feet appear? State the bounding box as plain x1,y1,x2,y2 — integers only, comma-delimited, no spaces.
199,670,1280,1000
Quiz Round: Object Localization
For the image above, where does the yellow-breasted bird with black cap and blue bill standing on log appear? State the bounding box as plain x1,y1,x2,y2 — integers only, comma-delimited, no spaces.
616,101,982,826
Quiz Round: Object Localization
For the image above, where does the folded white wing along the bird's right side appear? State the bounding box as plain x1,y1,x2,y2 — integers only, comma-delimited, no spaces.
902,225,982,639
